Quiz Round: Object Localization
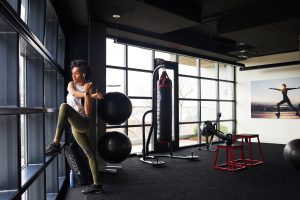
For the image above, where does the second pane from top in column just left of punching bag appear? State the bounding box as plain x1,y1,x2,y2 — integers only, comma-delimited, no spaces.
128,71,152,97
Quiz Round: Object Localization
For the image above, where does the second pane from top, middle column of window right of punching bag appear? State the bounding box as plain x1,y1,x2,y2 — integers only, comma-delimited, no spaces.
201,79,217,99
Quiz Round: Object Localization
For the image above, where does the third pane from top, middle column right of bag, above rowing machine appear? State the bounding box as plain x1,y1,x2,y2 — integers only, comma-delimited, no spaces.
201,101,217,121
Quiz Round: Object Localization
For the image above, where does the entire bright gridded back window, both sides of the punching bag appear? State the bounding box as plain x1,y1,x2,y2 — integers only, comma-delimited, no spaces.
106,38,235,153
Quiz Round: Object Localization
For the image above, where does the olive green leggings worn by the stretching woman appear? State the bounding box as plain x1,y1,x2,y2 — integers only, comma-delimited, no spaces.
55,103,100,184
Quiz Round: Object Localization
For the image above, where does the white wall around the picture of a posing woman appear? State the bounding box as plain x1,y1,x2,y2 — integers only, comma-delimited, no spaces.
236,52,300,144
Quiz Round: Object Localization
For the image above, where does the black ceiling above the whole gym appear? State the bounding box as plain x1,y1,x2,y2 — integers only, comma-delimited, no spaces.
56,0,300,61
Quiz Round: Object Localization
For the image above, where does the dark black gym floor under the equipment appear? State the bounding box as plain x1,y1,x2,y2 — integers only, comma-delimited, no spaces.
66,144,300,200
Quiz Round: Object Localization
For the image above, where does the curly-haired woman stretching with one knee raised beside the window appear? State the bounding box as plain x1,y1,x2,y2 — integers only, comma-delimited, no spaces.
45,60,103,193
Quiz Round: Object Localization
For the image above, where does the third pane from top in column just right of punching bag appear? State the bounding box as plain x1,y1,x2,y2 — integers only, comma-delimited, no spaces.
178,101,199,122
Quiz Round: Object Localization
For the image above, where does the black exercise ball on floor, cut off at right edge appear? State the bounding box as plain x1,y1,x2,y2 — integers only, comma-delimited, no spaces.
283,139,300,169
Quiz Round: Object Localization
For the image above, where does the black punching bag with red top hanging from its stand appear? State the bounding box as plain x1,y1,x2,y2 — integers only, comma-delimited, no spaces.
157,71,172,143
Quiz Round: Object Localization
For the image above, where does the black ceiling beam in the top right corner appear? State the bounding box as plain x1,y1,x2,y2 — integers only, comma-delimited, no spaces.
217,0,300,34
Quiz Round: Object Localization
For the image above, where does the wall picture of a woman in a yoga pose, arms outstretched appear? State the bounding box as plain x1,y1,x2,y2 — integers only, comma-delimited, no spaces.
251,77,300,119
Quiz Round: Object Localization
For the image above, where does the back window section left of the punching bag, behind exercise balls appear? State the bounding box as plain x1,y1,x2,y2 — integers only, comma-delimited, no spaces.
106,39,154,153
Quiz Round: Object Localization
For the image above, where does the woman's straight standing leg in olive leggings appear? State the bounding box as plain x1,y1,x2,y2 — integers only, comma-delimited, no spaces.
72,126,101,185
